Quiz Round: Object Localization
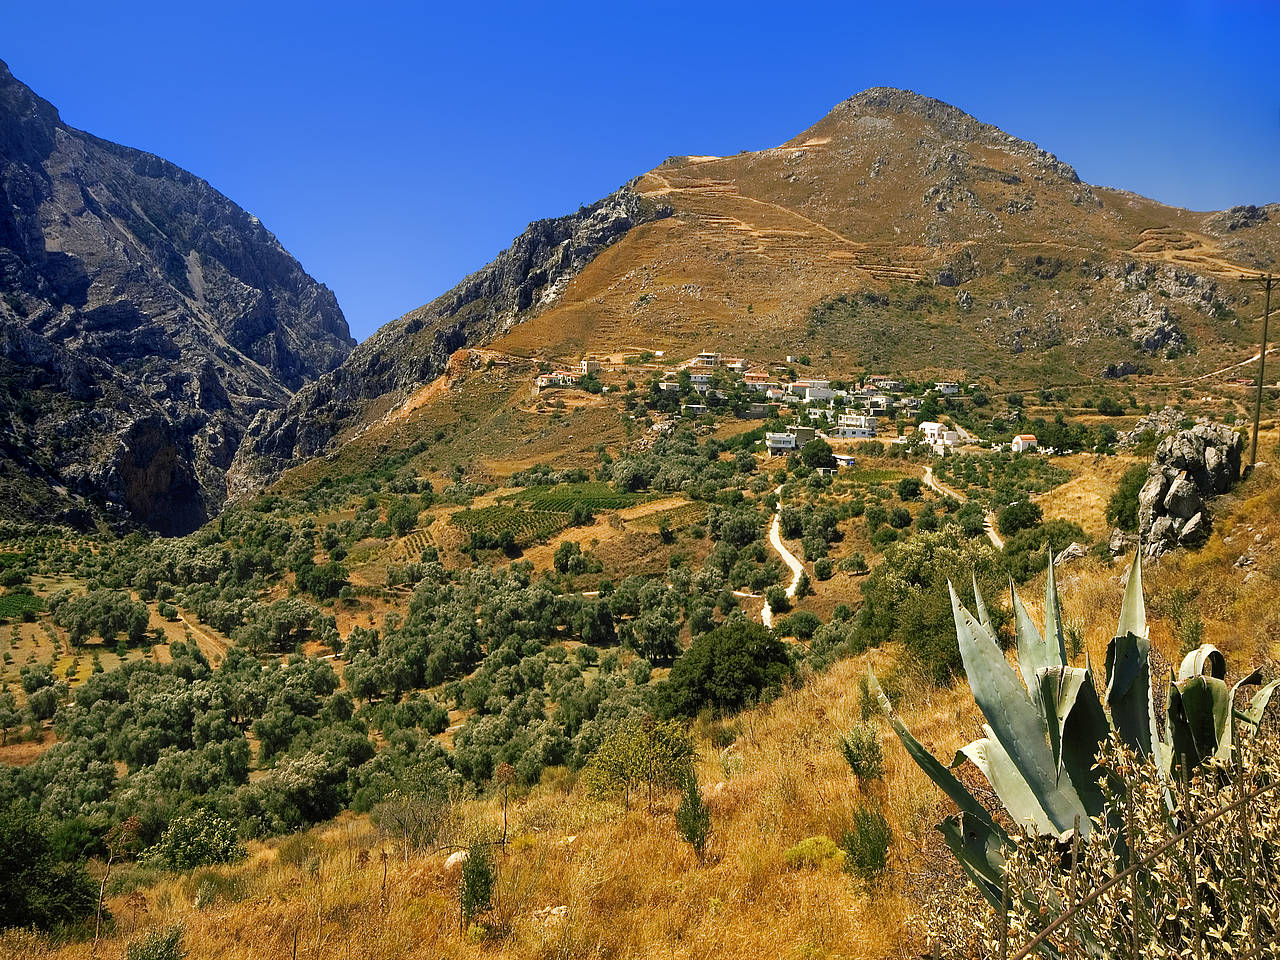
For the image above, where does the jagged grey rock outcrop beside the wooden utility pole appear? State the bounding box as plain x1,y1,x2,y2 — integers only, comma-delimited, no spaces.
1138,424,1243,557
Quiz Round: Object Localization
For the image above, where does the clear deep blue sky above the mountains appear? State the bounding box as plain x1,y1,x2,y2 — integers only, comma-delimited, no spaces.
0,0,1280,339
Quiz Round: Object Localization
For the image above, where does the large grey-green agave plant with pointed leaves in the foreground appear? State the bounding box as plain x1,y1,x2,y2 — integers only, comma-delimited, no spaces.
870,556,1280,908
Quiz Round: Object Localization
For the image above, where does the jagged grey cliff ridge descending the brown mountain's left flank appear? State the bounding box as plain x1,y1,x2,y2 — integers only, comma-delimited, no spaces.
228,184,671,497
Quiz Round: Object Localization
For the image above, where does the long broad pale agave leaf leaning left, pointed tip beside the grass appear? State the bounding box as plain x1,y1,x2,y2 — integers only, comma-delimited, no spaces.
951,589,1088,835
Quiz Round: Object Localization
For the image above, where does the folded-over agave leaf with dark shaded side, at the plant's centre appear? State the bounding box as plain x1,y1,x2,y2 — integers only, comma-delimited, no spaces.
1038,667,1111,819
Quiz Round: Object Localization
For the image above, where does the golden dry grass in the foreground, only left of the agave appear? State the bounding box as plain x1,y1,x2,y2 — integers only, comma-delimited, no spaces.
0,654,973,960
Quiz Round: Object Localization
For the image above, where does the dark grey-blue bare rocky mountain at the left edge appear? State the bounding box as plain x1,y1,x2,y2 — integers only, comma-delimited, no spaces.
0,63,355,532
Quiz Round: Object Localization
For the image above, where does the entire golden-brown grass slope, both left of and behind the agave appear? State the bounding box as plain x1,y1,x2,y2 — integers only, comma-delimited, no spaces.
12,467,1280,960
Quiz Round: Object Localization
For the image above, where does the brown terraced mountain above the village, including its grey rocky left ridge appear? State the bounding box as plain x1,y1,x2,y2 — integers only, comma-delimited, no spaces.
230,88,1280,493
